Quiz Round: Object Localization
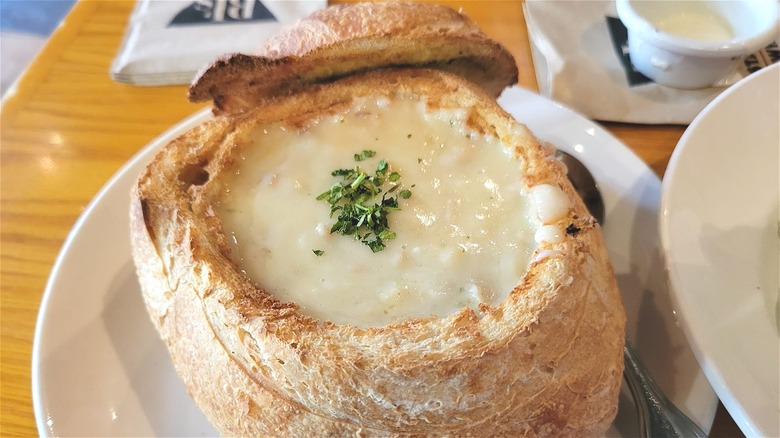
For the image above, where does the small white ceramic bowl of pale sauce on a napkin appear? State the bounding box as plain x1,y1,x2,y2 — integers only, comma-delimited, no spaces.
616,0,780,89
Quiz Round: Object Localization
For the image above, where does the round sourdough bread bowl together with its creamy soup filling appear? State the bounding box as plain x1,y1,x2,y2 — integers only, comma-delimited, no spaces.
131,1,625,436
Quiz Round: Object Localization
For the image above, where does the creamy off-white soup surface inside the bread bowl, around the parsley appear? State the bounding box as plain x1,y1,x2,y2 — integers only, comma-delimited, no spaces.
213,98,544,327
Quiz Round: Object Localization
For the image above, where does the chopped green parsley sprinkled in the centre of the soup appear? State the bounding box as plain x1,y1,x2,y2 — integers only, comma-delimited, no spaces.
314,150,412,256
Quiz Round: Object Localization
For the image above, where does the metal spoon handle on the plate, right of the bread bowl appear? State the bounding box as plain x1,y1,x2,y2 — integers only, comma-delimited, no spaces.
623,341,707,438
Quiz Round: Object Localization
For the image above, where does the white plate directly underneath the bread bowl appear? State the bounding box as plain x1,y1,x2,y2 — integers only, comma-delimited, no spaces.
32,88,717,436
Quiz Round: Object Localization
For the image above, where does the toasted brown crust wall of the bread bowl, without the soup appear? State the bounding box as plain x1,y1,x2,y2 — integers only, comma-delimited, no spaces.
131,69,625,436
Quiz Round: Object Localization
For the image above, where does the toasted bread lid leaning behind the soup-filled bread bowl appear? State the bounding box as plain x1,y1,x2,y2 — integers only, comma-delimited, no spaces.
189,2,518,113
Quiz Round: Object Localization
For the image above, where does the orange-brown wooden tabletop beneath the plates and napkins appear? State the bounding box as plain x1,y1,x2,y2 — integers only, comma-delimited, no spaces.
0,0,740,436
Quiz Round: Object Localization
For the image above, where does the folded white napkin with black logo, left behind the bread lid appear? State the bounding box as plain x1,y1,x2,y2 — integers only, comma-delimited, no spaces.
110,0,327,85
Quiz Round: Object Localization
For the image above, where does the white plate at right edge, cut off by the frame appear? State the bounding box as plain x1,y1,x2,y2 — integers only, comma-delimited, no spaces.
660,64,780,437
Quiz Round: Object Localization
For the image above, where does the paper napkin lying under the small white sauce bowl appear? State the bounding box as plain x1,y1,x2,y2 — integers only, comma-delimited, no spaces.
525,0,780,124
